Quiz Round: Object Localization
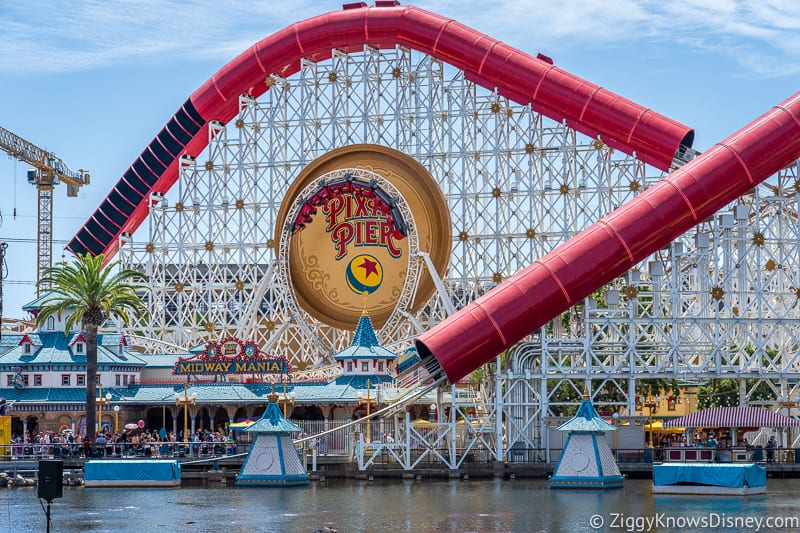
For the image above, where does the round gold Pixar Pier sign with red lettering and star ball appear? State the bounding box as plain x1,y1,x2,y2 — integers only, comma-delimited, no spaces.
275,144,451,329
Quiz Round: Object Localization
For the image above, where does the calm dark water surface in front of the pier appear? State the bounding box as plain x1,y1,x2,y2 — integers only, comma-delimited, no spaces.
0,479,800,533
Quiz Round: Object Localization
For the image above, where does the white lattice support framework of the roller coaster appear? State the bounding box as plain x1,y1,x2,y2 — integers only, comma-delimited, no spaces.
119,46,800,468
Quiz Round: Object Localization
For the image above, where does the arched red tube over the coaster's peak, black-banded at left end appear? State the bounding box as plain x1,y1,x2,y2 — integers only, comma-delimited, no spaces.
67,1,694,259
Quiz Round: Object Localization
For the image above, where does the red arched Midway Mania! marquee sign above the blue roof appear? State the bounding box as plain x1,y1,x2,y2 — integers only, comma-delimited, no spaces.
172,337,291,375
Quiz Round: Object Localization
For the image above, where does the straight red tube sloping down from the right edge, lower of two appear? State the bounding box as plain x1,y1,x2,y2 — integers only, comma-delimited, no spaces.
416,93,800,382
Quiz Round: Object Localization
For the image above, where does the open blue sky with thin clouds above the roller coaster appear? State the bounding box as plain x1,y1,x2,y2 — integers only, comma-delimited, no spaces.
0,0,800,317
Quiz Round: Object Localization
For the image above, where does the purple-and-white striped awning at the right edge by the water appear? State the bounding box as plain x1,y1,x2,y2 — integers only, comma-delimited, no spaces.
664,407,800,428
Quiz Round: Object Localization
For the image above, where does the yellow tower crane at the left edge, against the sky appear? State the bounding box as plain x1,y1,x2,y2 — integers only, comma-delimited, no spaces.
0,127,89,296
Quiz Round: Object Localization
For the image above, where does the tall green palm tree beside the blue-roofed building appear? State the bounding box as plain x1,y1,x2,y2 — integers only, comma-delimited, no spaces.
36,253,149,438
